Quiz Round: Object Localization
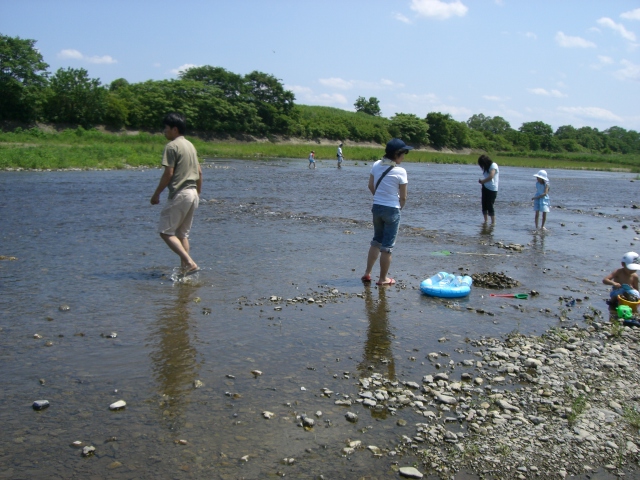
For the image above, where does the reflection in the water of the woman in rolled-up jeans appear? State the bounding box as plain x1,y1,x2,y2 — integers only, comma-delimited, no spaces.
358,287,396,381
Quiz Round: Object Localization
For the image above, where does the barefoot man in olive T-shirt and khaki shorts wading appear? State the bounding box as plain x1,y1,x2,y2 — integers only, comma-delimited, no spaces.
151,113,202,276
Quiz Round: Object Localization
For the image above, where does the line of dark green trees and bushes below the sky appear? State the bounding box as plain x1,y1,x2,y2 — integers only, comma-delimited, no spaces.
0,34,640,154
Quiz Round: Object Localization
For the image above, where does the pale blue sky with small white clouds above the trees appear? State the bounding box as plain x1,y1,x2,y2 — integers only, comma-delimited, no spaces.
0,0,640,131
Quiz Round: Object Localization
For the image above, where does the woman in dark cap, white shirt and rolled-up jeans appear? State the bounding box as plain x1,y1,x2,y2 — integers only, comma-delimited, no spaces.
361,138,413,286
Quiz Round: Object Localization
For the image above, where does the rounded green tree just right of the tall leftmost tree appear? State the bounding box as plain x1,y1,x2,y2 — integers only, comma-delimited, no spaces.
45,68,107,128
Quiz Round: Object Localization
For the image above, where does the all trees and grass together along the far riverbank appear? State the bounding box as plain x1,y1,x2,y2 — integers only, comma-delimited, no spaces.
0,35,640,172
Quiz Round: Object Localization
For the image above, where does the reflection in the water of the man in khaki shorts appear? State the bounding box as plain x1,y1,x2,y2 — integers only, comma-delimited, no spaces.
150,284,198,430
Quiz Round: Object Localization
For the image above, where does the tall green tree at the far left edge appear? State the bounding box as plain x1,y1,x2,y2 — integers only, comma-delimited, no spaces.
0,35,49,121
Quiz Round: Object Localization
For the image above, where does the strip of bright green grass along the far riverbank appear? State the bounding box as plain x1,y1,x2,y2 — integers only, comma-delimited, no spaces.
0,129,640,173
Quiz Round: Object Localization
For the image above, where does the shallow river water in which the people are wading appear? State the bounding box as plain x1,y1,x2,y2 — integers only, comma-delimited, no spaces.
0,159,640,479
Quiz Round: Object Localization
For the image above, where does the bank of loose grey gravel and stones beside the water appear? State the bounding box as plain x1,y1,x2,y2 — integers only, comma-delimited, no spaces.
335,313,640,479
